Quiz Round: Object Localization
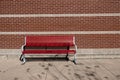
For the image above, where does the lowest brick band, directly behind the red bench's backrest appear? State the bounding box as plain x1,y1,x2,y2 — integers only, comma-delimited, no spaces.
0,34,120,49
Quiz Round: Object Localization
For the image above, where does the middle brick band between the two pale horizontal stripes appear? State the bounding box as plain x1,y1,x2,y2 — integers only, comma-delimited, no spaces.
0,16,120,32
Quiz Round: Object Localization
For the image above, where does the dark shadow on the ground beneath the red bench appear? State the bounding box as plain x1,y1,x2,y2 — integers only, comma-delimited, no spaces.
26,57,69,62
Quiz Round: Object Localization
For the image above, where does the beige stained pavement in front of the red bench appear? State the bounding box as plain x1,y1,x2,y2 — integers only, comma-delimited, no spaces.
0,58,120,80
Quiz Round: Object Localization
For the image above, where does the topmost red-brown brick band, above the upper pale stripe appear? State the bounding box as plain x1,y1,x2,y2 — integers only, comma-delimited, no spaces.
0,0,120,14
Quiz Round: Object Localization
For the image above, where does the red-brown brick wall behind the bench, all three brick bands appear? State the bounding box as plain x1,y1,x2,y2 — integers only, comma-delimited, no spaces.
0,0,120,49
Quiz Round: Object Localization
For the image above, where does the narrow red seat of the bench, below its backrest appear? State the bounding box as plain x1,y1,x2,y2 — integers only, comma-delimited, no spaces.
22,50,76,54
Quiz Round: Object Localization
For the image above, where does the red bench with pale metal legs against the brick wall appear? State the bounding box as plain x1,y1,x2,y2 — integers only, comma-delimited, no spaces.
20,36,77,63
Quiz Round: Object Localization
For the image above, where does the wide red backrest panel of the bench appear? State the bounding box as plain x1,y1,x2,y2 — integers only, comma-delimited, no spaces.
25,36,75,46
